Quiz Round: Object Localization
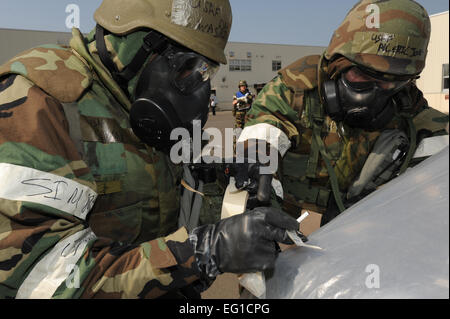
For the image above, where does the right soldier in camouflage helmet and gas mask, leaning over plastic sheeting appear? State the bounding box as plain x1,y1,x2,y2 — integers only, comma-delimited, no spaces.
239,0,448,224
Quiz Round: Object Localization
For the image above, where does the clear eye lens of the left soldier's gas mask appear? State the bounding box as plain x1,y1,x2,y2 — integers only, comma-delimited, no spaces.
173,53,219,94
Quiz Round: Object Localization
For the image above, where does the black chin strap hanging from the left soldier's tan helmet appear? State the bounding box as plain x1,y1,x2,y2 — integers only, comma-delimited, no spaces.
95,24,168,97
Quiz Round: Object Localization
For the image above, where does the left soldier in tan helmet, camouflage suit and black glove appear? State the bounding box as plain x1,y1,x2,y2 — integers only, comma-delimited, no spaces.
0,0,298,298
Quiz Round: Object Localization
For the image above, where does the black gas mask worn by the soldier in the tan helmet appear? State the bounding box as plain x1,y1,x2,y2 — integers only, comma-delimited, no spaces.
130,39,219,151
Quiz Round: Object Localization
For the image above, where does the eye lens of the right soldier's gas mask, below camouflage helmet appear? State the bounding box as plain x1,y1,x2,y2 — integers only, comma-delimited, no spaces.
343,67,410,91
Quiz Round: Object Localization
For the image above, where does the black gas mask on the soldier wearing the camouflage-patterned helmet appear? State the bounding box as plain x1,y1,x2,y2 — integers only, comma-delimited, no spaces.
323,67,410,131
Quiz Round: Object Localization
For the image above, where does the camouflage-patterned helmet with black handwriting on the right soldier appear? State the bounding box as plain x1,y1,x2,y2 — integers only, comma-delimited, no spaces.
324,0,431,77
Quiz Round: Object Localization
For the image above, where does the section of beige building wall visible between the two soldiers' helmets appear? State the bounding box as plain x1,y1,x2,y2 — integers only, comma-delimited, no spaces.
212,42,326,110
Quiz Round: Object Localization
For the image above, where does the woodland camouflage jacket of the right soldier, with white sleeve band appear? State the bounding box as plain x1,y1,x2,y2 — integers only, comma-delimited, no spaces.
239,55,448,215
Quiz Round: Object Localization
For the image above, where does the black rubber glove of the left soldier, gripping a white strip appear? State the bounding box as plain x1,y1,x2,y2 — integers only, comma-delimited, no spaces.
189,207,299,282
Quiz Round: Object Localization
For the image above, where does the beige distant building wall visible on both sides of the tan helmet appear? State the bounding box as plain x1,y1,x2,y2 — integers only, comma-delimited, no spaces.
0,29,325,110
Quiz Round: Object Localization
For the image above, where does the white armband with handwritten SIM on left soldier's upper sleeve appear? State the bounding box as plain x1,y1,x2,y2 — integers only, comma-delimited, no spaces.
0,163,98,220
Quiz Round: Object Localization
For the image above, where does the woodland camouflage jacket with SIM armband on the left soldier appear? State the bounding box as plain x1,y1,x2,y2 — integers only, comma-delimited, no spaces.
0,29,198,298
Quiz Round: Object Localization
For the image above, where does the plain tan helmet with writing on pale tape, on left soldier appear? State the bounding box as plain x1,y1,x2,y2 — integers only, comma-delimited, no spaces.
94,0,232,64
